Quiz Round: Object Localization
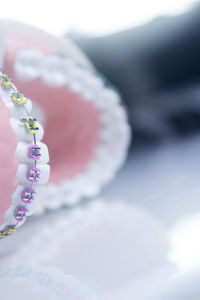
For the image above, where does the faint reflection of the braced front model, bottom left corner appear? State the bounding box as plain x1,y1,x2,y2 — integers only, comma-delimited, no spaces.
0,265,97,300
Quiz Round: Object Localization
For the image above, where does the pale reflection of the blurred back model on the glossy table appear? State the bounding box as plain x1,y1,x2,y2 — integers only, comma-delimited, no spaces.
2,200,174,300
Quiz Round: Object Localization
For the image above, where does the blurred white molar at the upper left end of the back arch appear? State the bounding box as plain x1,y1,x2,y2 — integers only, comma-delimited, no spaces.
14,49,44,80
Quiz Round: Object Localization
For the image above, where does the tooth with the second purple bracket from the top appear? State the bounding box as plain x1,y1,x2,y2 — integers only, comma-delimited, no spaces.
16,164,50,187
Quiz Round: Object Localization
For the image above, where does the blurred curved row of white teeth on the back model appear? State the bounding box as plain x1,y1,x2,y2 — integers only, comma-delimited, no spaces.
14,49,130,211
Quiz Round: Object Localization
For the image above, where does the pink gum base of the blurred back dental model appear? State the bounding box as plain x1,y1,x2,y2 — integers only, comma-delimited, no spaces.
3,31,100,183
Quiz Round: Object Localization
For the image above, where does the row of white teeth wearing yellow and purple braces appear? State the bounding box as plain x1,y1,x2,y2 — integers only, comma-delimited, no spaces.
0,72,50,239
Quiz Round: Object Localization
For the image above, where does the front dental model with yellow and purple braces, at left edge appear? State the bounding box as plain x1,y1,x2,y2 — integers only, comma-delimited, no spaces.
0,71,50,239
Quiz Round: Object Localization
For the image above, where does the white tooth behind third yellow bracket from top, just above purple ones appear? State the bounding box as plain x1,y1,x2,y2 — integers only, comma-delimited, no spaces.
10,118,44,142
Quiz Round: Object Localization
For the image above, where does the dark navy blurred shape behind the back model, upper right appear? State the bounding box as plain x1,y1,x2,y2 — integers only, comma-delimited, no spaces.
68,3,200,145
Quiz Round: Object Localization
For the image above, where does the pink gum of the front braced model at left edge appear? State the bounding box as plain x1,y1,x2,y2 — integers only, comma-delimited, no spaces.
0,97,18,225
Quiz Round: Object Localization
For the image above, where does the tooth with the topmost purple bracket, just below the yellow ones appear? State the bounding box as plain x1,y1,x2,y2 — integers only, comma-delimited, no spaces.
15,142,49,165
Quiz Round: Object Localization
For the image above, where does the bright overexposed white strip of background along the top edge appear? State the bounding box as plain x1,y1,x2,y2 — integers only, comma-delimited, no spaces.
0,0,194,36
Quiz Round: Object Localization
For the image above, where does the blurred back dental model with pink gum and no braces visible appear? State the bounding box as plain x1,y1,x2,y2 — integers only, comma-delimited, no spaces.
0,21,130,211
